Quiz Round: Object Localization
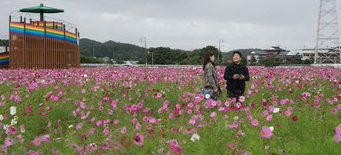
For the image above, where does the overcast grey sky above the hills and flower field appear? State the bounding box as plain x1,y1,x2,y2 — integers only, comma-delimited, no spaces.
0,0,340,52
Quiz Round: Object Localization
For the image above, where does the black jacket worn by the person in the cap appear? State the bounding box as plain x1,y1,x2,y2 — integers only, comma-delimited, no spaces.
224,63,250,95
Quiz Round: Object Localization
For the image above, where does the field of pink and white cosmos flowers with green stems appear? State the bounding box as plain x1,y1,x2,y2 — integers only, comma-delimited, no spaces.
0,67,341,155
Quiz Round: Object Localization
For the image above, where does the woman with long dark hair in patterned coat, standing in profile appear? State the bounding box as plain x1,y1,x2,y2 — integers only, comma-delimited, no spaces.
203,52,221,100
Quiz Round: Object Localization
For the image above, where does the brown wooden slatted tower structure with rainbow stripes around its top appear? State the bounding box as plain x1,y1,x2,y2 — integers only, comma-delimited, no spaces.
9,16,80,69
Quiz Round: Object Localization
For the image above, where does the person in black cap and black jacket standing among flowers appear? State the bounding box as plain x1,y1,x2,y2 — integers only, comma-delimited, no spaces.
224,51,250,102
